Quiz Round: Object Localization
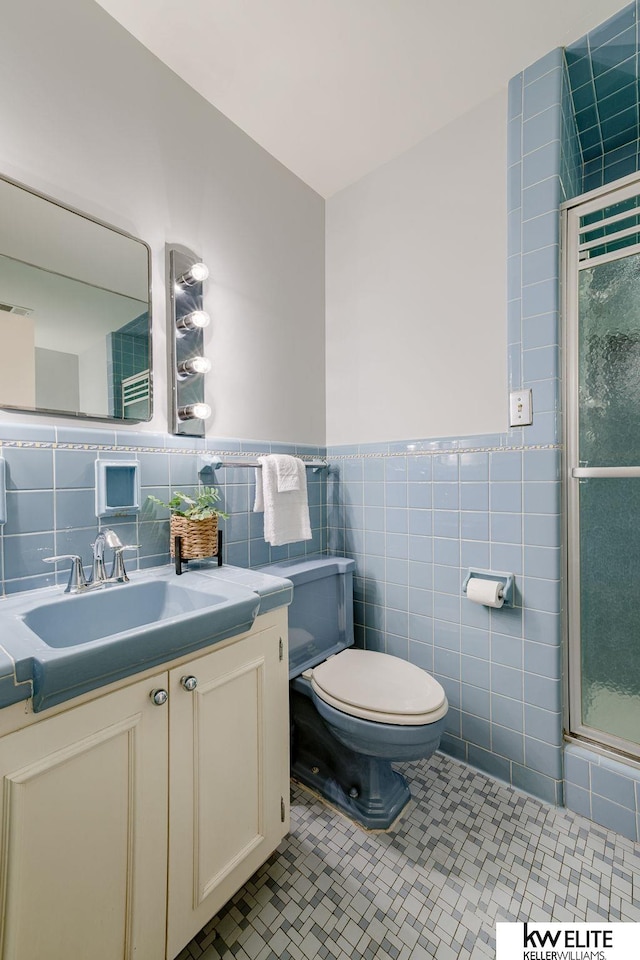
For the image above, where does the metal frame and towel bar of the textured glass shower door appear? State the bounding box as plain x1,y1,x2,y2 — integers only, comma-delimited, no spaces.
560,172,640,761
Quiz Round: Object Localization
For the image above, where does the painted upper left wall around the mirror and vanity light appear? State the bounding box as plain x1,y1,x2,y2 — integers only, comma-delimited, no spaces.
0,0,325,443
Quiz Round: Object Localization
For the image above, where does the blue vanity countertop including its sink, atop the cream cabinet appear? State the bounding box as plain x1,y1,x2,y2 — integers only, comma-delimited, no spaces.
0,561,293,712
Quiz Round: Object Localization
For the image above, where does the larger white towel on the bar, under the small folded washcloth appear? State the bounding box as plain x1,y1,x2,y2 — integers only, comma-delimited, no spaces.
253,455,311,547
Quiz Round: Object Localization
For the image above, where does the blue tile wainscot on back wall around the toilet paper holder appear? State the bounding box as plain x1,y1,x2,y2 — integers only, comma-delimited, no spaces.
327,431,562,803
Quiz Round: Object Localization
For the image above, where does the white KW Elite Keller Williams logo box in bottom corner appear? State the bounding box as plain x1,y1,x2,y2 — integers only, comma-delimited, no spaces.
496,923,640,960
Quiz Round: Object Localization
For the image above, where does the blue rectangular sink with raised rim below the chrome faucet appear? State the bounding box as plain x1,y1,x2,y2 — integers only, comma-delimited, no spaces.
0,568,260,711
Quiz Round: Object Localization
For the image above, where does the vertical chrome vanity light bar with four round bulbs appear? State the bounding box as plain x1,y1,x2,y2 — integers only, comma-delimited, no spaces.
167,246,211,437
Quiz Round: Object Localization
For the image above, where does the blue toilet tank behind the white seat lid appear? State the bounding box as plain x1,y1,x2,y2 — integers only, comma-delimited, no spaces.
260,556,355,678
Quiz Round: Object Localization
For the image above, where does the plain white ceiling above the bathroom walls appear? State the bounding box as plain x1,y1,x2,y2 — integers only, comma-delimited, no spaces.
99,0,625,197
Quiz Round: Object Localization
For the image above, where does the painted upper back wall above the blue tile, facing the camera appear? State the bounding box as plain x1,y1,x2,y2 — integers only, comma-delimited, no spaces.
326,91,507,444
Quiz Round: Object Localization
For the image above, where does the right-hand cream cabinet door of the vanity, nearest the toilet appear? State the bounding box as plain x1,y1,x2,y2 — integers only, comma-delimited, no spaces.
167,609,289,960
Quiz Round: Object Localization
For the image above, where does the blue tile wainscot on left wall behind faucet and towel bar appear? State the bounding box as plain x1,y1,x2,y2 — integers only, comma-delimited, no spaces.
0,423,326,594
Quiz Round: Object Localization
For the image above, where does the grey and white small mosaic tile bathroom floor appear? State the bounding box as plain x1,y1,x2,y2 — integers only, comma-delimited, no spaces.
178,755,640,960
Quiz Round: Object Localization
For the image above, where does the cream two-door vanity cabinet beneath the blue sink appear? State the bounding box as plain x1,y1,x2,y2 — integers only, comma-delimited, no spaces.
0,608,289,960
